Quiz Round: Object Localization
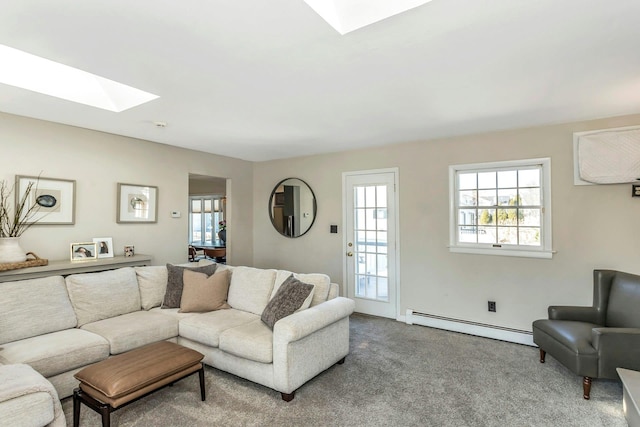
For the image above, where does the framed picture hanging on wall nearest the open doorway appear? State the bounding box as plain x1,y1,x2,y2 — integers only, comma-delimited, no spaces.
116,183,158,224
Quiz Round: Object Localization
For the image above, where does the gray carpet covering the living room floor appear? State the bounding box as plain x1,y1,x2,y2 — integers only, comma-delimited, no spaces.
63,315,627,427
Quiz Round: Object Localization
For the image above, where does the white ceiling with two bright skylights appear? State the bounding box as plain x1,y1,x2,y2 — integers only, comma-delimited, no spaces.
0,0,640,161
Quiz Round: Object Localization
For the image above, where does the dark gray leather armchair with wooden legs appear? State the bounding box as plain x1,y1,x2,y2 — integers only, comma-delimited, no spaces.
533,270,640,399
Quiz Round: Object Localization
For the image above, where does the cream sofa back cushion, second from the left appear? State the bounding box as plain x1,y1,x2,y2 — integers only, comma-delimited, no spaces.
66,267,140,326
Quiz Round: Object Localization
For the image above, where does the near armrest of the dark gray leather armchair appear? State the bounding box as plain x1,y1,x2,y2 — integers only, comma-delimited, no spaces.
591,328,640,379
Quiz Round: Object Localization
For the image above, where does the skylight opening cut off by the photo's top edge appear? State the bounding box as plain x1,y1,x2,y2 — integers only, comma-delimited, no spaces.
304,0,431,35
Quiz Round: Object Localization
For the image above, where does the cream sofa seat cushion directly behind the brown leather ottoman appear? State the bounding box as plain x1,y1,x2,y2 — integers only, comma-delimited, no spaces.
82,311,178,354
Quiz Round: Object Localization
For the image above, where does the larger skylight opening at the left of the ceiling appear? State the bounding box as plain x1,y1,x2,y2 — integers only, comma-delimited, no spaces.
0,44,158,113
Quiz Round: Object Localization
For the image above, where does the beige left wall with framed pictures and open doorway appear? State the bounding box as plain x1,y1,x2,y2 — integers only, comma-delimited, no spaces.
0,113,253,265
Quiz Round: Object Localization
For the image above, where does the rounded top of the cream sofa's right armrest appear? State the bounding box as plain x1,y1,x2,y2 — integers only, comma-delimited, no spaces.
273,297,356,342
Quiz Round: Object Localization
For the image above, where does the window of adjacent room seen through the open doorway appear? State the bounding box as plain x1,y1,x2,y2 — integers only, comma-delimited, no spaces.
189,196,224,245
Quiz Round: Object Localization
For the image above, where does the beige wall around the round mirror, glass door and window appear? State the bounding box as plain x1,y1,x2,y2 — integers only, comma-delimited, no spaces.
254,115,640,330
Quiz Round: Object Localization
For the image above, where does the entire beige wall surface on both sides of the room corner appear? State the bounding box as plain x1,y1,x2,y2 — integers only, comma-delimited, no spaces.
6,109,640,330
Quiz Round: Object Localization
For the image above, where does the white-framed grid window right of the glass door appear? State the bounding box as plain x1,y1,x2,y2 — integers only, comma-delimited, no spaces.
449,158,553,258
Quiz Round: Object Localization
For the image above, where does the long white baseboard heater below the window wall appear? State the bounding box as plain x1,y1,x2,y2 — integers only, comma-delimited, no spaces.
405,309,535,346
